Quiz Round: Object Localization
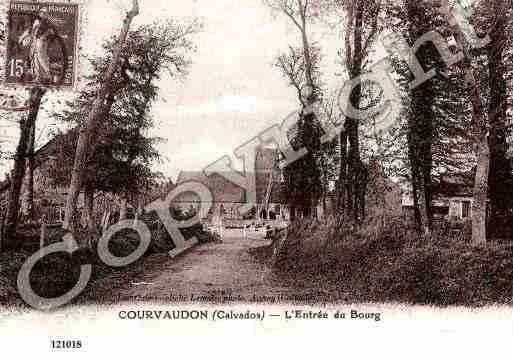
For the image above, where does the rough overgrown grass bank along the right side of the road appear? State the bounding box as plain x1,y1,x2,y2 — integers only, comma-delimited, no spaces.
273,218,513,307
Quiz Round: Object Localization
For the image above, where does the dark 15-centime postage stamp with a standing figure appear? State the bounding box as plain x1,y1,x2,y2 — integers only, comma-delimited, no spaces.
5,1,79,88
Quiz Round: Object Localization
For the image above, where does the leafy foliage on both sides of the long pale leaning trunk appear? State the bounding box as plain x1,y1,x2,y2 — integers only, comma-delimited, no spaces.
47,20,201,201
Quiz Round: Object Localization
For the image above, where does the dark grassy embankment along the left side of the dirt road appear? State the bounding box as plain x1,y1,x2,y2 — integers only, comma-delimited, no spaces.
0,214,215,307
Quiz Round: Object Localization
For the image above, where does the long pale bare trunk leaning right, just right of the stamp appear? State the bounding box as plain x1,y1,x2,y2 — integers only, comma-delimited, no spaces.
64,0,139,233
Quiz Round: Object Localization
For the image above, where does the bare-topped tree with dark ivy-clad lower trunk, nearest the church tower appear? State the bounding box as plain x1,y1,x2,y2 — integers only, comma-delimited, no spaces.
265,0,322,217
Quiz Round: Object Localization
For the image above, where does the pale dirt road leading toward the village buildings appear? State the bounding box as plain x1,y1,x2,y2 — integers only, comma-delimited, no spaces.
83,230,297,302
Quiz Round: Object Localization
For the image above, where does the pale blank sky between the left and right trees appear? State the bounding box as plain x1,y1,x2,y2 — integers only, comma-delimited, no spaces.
0,0,344,179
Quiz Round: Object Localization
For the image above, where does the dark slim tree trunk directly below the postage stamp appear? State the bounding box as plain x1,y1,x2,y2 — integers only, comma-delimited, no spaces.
4,88,45,239
